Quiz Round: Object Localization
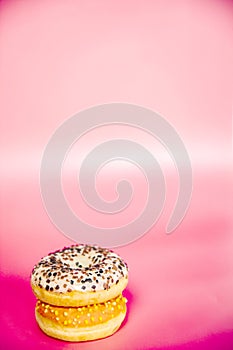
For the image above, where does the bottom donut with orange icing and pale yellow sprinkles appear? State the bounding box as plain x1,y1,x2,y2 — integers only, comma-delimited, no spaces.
35,295,127,341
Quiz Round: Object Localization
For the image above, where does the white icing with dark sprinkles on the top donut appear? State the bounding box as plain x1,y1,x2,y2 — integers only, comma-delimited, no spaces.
31,245,128,293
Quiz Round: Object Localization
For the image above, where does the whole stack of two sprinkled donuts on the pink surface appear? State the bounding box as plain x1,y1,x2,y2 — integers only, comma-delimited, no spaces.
31,245,128,341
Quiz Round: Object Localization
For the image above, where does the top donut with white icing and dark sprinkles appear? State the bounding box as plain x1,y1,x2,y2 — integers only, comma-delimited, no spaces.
31,245,128,307
